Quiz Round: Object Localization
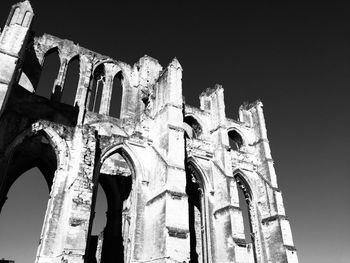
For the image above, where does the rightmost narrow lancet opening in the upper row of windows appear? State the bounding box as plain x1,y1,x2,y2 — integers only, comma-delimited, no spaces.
109,71,123,118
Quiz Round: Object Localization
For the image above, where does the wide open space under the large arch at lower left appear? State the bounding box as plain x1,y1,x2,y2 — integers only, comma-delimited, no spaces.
0,135,57,263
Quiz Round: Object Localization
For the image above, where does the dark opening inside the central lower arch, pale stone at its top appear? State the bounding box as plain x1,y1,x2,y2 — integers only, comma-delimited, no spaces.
88,153,132,263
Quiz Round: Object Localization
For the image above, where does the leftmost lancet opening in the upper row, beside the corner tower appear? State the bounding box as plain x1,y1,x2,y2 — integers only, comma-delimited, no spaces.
35,48,61,99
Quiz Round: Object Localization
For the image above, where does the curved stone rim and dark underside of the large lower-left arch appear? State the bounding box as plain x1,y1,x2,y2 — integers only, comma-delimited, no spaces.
0,122,69,262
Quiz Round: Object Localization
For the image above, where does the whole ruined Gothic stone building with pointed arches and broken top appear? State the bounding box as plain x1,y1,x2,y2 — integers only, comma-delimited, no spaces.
0,1,298,263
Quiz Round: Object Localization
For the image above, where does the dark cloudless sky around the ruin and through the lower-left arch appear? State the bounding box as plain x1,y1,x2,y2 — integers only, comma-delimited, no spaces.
0,0,350,263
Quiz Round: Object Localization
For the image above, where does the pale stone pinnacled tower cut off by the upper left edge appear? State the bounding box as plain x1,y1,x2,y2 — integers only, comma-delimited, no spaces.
0,1,34,114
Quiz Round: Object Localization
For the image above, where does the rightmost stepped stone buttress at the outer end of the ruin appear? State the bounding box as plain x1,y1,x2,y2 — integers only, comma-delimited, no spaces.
240,101,298,263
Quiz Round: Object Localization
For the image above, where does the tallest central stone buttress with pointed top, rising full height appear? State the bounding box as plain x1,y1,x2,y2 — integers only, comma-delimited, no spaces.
144,59,190,263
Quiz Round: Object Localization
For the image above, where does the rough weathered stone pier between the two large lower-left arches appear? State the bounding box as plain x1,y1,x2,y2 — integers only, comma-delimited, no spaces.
61,127,97,263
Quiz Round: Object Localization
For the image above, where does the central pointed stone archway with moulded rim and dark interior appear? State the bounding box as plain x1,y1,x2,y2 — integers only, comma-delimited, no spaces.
87,145,143,263
